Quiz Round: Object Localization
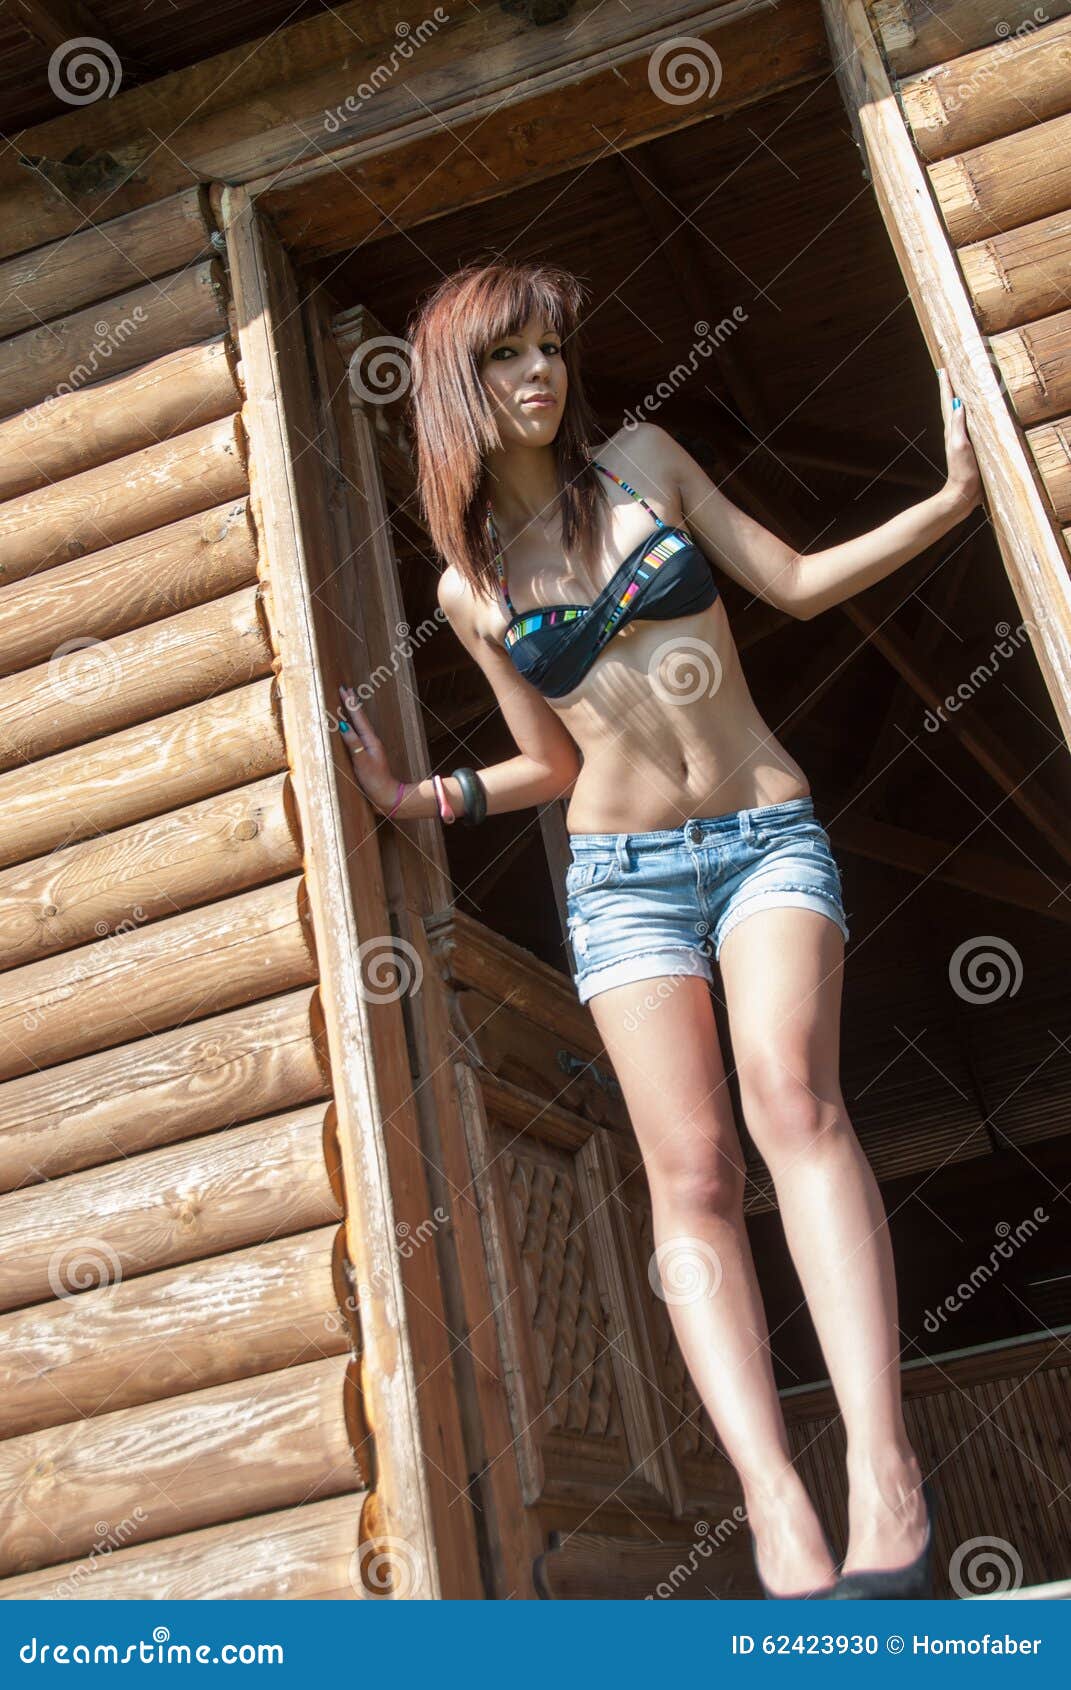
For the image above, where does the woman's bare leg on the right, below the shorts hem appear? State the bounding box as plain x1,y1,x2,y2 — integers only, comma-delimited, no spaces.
720,908,926,1572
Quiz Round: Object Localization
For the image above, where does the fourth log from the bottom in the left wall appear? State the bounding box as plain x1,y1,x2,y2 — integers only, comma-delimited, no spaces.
0,1104,343,1318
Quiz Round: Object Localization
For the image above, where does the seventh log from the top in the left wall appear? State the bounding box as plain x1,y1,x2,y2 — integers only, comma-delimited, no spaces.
0,679,287,865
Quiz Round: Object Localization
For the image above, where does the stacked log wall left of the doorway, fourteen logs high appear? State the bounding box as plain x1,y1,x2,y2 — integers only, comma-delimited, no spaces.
0,188,373,1599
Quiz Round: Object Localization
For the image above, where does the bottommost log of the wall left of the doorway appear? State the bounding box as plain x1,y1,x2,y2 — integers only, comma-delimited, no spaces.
0,1491,368,1602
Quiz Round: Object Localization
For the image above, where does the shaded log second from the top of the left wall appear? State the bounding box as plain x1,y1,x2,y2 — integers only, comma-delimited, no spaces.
0,259,228,425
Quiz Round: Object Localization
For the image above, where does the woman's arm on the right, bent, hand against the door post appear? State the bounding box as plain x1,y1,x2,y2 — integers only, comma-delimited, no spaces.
661,370,981,620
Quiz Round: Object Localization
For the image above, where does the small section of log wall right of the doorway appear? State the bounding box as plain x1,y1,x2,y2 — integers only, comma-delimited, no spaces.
870,0,1071,544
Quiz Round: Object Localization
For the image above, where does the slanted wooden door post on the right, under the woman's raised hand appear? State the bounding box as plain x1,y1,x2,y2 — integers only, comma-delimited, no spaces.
823,0,1071,753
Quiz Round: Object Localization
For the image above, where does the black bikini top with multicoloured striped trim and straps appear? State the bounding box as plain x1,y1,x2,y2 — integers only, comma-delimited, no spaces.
487,460,718,698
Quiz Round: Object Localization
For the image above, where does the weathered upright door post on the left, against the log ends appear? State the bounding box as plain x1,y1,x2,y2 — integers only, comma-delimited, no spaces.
221,188,469,1597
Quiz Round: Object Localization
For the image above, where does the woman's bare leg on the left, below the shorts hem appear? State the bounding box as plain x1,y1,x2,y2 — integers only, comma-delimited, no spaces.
588,975,836,1592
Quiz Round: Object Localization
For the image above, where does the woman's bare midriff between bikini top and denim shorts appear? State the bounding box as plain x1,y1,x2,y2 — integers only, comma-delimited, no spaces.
549,598,811,833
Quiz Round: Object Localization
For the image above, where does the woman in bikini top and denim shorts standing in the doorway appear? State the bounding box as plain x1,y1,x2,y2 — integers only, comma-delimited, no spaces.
340,264,980,1595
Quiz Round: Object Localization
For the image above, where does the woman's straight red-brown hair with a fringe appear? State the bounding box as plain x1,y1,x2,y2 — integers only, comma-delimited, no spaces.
409,260,606,597
